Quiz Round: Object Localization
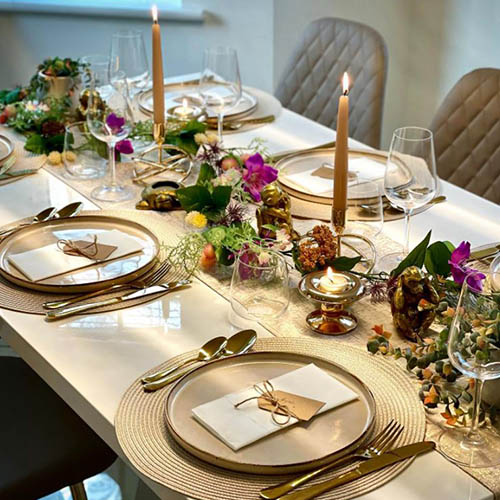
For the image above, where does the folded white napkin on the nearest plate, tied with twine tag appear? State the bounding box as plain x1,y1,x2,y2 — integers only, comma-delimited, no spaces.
192,364,358,451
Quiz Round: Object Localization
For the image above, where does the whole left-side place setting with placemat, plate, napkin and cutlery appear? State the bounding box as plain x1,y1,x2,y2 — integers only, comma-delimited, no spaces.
0,202,191,321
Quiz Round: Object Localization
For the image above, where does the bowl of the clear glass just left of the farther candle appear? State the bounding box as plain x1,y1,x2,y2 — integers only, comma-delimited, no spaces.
109,30,150,97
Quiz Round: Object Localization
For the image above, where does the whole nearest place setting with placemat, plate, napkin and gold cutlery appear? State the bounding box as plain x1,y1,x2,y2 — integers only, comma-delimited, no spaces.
115,330,428,499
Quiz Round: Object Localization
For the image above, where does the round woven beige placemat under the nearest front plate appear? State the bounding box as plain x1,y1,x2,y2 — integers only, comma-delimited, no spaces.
115,338,425,500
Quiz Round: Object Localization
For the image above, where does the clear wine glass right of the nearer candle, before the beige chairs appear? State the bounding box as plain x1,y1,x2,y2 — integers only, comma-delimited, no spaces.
381,127,437,269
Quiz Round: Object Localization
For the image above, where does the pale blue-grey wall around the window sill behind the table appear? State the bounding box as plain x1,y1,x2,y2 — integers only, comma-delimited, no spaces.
0,0,273,91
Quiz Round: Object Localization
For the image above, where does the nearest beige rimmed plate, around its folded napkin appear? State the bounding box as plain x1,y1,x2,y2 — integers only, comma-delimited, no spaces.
165,352,375,474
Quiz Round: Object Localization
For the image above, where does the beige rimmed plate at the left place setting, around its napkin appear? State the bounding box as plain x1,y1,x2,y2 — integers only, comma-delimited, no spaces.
0,215,160,294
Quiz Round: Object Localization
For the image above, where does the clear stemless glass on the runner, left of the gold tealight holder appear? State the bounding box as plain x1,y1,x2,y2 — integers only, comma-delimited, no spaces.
231,248,290,321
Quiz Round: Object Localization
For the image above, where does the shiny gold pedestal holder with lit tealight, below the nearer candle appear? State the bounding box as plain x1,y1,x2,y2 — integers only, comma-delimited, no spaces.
299,268,364,335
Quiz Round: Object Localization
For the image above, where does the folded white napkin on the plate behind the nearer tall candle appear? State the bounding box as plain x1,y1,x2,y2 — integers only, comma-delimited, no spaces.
287,157,385,194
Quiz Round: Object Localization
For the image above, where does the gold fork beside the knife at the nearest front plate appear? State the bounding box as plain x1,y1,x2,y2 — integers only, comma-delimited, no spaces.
260,420,404,500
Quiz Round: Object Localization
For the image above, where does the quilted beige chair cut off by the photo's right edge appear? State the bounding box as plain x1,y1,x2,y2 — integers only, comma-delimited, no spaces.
431,68,500,203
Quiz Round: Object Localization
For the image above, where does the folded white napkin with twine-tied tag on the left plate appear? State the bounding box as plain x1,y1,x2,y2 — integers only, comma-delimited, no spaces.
9,229,142,281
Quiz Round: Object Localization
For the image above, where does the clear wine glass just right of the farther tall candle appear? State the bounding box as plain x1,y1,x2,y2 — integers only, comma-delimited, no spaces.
200,47,241,142
